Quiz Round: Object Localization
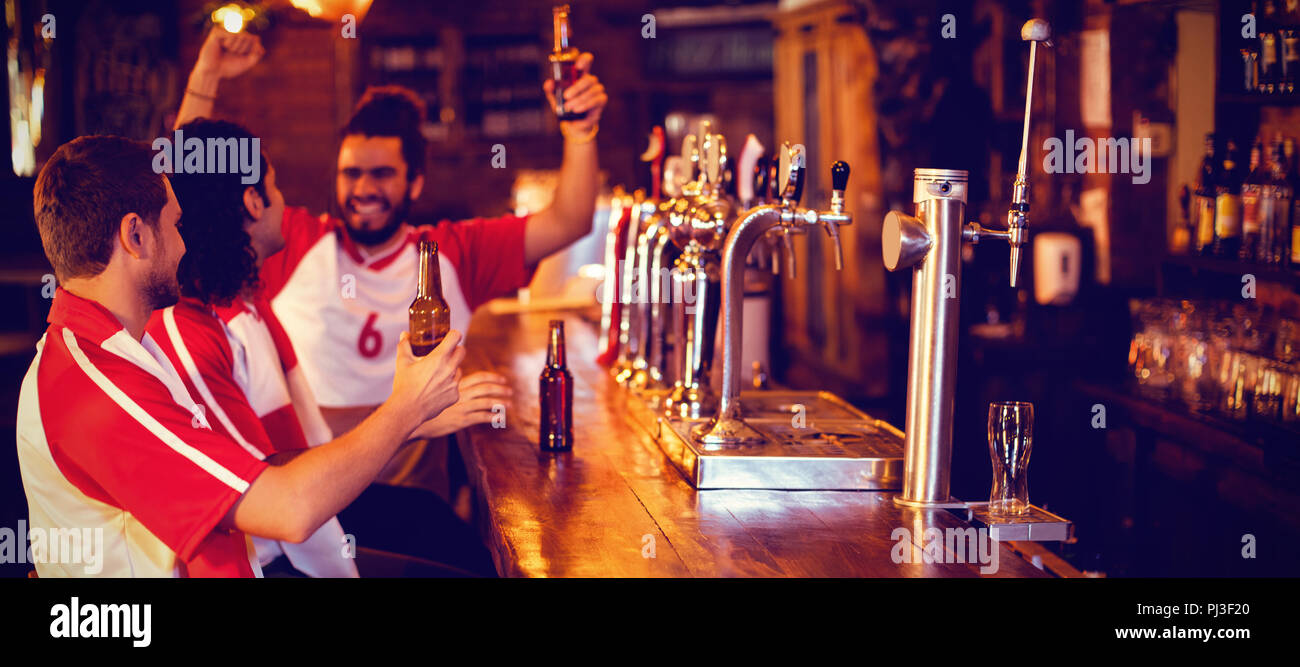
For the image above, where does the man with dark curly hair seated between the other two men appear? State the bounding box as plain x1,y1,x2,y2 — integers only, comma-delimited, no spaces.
147,118,495,577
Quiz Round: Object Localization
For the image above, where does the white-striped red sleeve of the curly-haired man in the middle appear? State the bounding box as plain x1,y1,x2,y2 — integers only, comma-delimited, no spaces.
148,302,288,458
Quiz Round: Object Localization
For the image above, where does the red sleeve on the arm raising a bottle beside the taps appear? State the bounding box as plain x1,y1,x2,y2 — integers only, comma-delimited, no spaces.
421,216,533,311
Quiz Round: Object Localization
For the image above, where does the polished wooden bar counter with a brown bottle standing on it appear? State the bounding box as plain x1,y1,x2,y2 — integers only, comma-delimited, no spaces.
459,308,1050,577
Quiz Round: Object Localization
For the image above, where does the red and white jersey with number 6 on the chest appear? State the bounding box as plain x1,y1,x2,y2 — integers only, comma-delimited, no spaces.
261,208,532,407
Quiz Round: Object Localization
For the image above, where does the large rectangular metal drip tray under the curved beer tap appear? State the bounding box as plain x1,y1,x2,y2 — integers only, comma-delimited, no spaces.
628,391,904,490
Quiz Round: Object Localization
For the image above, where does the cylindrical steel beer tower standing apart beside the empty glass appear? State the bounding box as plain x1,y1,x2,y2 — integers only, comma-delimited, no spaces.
880,18,1052,507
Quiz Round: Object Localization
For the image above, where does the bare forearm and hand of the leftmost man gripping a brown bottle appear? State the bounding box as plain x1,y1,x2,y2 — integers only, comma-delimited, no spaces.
222,332,465,542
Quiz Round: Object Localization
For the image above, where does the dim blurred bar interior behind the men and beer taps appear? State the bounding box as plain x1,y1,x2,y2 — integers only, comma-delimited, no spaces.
0,0,1300,576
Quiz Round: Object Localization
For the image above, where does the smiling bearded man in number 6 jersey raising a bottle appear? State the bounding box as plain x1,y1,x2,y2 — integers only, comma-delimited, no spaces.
177,29,608,494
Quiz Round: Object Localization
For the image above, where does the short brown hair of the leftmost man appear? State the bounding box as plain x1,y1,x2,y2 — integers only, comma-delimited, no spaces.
33,135,166,282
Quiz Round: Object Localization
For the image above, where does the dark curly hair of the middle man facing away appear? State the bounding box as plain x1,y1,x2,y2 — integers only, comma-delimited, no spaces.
170,118,270,306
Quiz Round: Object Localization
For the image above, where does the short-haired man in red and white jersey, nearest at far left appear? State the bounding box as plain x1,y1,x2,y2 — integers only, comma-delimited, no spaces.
17,137,463,576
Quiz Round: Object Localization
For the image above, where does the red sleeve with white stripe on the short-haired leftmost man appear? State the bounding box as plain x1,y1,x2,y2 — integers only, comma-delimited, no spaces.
38,328,267,562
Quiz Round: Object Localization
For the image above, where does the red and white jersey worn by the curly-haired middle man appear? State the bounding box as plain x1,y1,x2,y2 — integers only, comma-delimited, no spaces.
147,298,358,577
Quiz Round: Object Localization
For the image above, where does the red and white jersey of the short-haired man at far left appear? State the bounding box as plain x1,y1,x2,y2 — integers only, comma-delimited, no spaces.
17,289,267,577
